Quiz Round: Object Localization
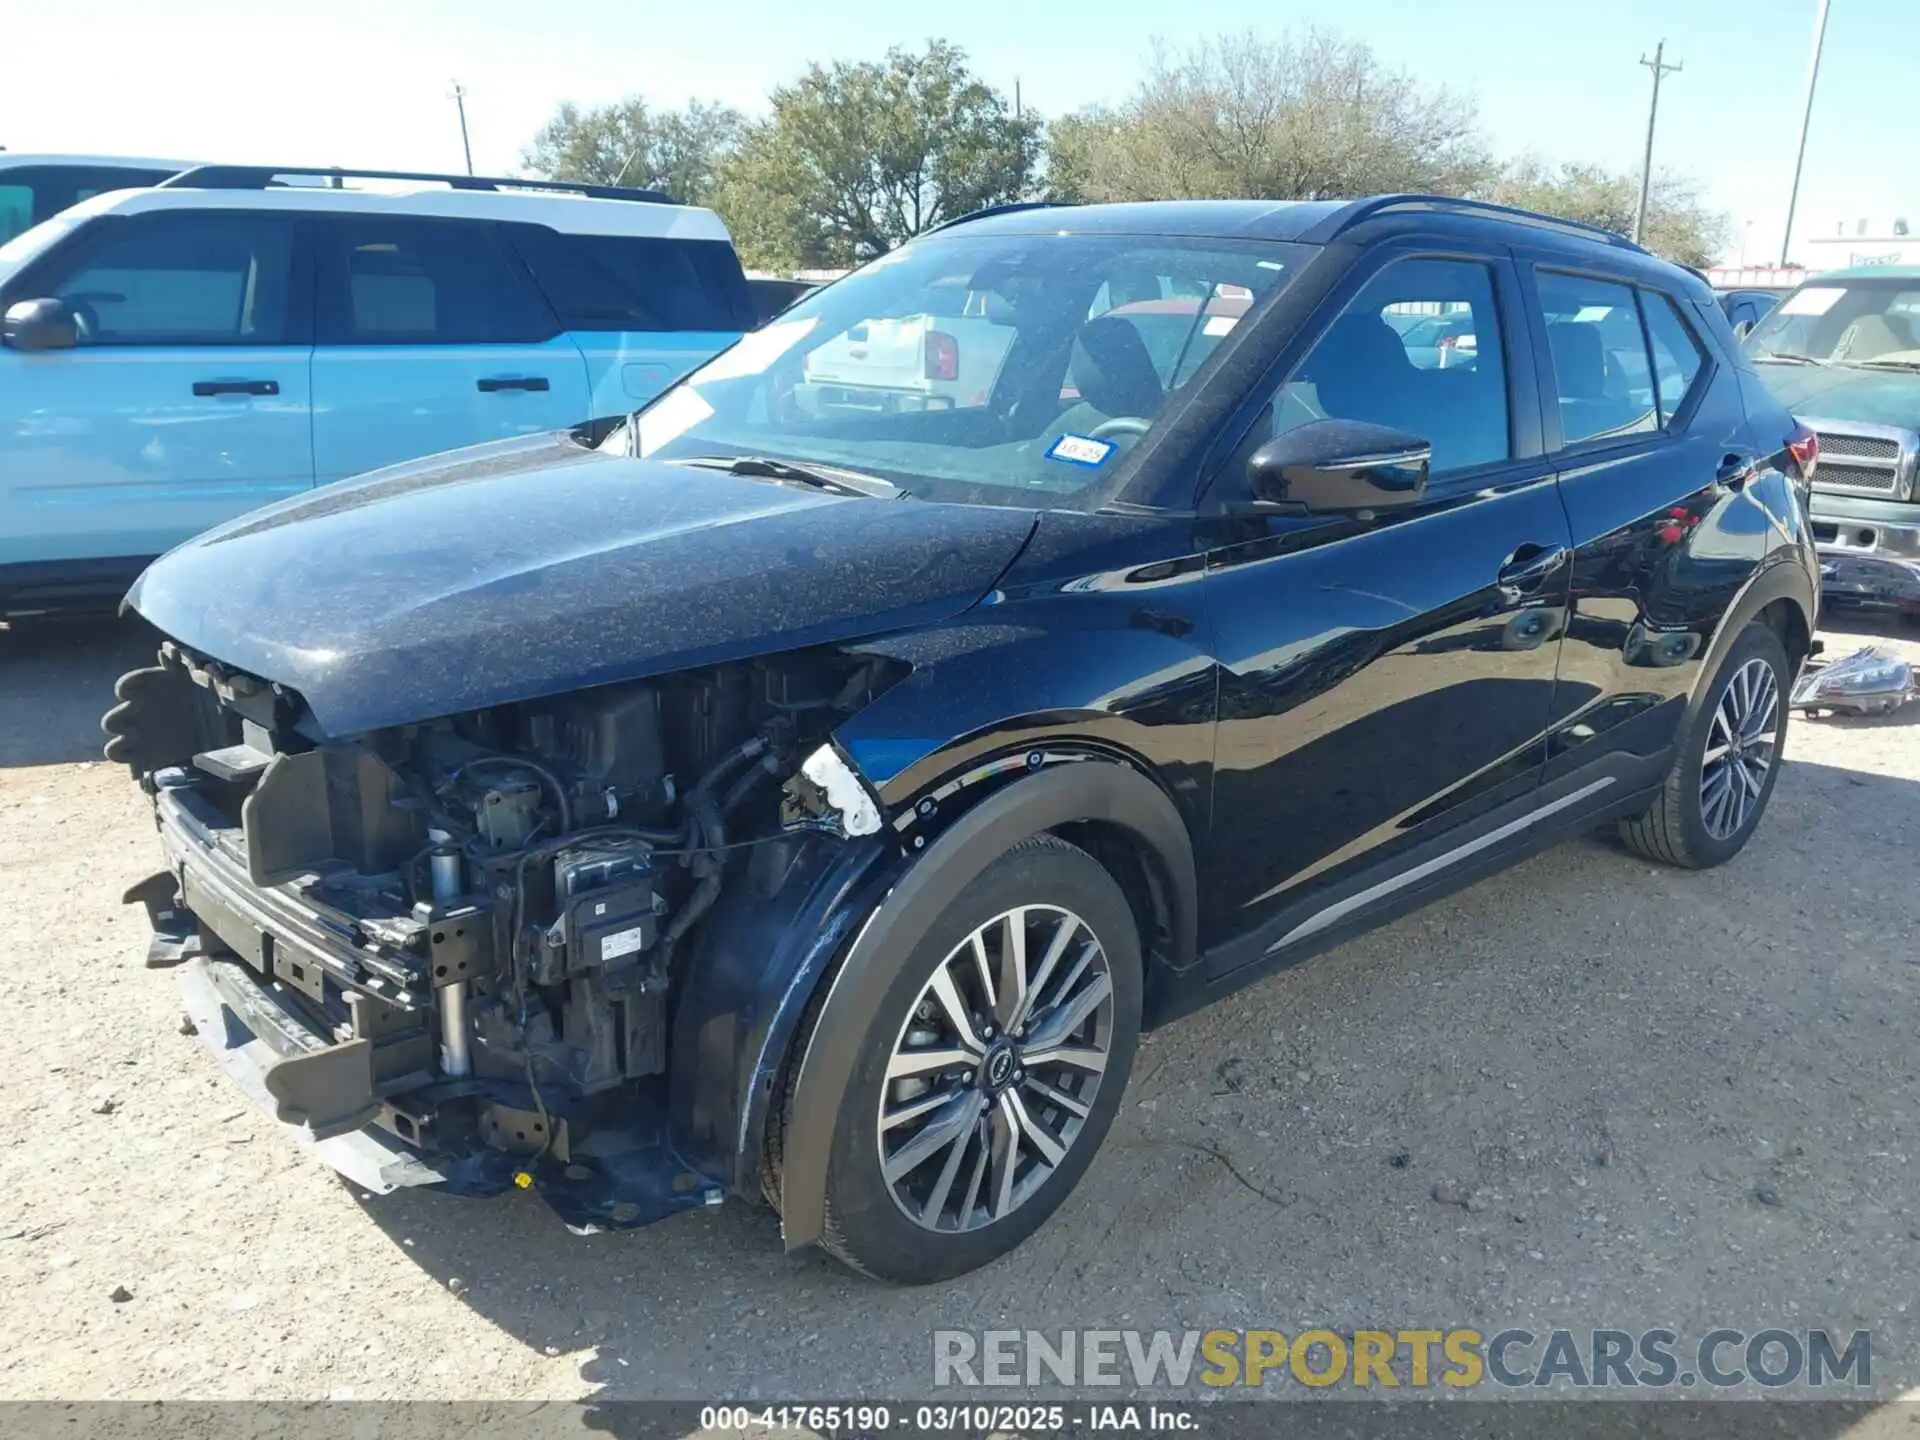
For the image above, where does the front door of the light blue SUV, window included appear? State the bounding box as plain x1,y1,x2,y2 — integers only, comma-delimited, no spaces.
0,207,313,563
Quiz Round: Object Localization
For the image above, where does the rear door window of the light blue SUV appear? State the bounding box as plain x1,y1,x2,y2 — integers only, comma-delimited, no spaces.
319,217,559,346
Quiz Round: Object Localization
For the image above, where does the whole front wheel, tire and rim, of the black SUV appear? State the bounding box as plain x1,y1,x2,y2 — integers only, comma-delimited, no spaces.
801,835,1140,1284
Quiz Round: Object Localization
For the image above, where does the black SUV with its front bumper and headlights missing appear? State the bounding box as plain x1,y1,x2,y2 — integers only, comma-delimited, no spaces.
106,196,1818,1281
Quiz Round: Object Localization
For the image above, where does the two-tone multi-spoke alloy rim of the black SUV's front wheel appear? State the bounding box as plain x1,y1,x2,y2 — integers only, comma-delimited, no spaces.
877,904,1114,1233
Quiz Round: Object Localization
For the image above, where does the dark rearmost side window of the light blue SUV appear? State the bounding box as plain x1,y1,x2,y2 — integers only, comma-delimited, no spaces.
513,225,758,332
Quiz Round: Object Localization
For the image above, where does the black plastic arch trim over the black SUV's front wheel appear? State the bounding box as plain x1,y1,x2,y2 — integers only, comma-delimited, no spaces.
780,760,1198,1250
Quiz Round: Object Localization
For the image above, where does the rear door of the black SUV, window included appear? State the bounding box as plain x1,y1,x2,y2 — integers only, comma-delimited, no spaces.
1526,257,1770,793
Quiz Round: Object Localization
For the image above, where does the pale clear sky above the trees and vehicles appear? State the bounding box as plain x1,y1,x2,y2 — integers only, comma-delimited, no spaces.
0,0,1920,259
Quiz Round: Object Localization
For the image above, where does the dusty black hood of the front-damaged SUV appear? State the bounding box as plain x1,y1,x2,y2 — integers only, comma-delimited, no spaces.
127,436,1035,735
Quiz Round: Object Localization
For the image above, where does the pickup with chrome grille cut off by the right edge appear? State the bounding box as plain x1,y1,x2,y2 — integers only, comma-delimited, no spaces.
1743,265,1920,620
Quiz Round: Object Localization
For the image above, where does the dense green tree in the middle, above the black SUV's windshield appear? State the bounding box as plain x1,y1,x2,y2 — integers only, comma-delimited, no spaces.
714,40,1043,267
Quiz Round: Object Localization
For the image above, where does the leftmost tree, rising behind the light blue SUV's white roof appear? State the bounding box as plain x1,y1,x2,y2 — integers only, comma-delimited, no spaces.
520,96,743,204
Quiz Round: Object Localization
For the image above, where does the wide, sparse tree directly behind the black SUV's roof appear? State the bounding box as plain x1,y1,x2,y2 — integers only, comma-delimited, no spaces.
1046,29,1496,200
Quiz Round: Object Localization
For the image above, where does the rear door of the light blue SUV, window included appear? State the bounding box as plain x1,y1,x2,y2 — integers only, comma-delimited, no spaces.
313,215,591,484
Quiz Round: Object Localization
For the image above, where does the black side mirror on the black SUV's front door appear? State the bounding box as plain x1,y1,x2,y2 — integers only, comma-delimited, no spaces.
1246,420,1432,515
